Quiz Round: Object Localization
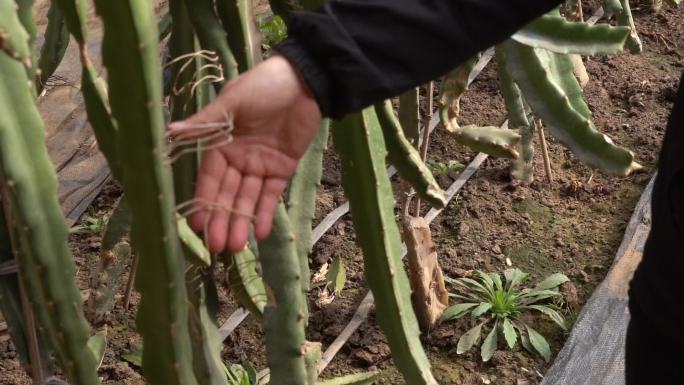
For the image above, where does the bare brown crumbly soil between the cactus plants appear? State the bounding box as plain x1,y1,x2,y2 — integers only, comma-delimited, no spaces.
0,5,684,385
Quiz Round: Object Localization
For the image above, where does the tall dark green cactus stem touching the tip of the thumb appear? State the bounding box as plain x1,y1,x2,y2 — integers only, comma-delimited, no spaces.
95,0,197,385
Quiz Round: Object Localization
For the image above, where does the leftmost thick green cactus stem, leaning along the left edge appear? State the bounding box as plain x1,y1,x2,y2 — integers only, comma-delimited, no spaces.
0,23,99,385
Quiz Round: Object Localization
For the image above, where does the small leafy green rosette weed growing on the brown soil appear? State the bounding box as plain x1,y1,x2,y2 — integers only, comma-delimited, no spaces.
441,269,569,362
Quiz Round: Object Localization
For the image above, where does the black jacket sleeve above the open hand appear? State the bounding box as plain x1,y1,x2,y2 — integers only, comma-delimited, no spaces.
276,0,560,118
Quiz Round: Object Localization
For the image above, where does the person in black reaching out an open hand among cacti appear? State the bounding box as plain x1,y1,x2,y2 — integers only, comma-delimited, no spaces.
169,0,684,385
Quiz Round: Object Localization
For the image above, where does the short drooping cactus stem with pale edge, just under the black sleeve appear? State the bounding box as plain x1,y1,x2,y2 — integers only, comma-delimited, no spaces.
375,100,446,208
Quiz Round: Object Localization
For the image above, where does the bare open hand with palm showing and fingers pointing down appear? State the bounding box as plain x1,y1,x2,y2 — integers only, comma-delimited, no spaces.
168,56,321,252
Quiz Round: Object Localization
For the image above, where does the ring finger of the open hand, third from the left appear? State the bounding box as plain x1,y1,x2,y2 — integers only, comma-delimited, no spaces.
228,175,263,252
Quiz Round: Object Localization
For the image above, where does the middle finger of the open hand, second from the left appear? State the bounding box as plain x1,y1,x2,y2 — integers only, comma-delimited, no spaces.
207,167,242,253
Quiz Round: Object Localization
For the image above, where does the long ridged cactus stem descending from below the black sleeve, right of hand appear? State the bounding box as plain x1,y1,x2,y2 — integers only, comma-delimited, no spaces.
333,108,437,385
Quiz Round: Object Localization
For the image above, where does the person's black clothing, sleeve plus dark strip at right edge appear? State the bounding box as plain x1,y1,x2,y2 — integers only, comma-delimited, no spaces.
277,0,684,385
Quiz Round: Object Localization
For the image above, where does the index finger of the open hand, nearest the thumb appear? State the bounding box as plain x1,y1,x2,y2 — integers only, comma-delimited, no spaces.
190,150,228,231
